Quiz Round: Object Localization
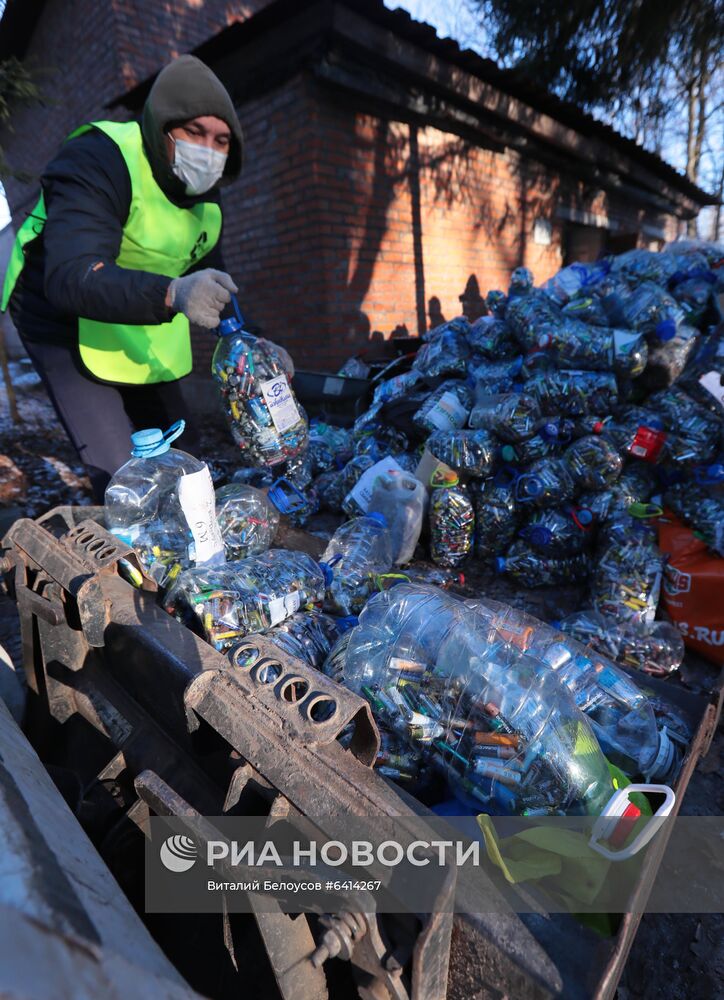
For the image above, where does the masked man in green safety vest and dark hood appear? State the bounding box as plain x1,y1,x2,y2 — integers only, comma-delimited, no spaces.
0,56,242,501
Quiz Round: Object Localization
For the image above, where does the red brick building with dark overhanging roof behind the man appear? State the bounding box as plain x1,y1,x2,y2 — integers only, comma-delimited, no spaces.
0,0,711,369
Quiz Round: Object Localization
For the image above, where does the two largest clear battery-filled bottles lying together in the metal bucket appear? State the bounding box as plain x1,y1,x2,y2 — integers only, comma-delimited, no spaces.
324,584,676,815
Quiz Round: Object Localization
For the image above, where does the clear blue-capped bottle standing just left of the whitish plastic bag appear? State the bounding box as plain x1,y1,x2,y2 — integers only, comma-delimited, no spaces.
322,513,393,615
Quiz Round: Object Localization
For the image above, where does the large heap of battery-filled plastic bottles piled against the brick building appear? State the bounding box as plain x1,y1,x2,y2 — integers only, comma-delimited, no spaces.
292,242,724,669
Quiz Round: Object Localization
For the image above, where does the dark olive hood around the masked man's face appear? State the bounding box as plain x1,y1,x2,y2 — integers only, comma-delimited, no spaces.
141,55,244,203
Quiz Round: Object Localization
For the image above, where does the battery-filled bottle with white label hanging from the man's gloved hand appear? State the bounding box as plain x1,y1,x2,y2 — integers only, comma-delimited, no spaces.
211,299,309,466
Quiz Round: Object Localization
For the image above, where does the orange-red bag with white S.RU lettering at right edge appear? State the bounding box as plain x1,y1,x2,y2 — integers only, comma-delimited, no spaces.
659,511,724,664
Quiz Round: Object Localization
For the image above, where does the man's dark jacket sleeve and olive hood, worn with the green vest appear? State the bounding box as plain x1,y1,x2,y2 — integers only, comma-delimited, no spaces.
10,56,243,344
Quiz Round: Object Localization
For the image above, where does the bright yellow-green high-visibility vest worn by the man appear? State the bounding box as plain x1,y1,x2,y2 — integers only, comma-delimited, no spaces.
0,122,221,385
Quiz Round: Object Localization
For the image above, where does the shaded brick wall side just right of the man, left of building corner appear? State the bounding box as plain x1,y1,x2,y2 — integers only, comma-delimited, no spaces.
194,75,331,371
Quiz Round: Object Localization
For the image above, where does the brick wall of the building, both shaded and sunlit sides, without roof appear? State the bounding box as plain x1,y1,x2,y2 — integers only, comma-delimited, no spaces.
204,75,680,371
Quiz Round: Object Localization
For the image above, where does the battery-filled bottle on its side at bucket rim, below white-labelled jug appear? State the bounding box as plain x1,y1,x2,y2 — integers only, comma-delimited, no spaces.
165,549,331,650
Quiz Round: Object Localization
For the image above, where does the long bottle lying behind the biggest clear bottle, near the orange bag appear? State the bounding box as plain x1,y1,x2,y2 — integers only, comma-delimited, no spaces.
466,599,678,781
